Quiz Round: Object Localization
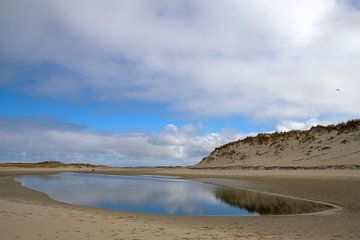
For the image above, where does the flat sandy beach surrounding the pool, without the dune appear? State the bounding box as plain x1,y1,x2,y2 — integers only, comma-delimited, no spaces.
0,168,360,240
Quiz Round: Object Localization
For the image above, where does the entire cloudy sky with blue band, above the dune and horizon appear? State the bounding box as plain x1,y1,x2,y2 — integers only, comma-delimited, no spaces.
0,0,360,166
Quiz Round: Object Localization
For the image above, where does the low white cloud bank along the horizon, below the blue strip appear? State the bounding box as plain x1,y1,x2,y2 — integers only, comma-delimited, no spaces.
0,117,243,166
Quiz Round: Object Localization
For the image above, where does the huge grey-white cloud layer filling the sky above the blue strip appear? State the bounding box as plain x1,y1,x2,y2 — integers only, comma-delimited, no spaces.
0,0,360,119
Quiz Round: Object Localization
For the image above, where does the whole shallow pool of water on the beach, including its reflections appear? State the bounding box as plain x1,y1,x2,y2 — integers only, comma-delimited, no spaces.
15,173,328,216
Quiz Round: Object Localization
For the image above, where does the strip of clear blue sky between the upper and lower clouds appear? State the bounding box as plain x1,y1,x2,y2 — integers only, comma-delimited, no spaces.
0,90,273,133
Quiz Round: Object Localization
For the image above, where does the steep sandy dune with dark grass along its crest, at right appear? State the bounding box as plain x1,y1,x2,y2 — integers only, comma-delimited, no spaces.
194,119,360,169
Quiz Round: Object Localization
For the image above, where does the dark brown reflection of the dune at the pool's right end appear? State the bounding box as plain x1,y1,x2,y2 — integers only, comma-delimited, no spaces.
215,188,331,215
